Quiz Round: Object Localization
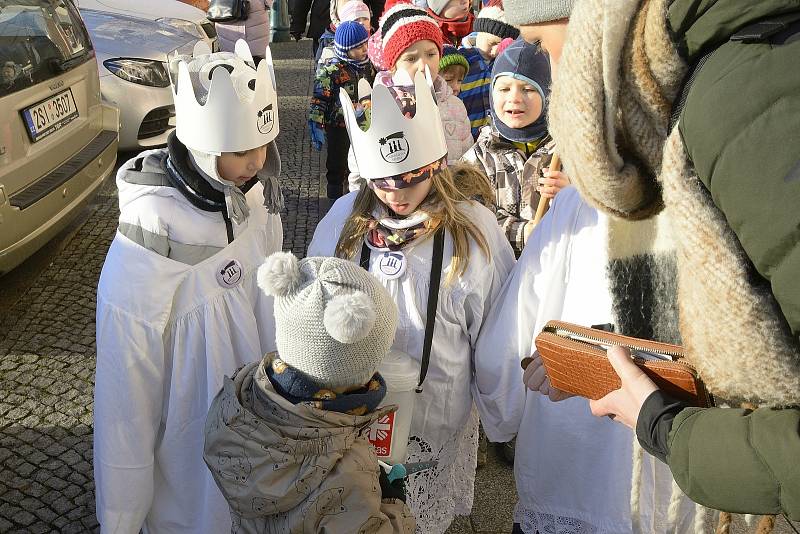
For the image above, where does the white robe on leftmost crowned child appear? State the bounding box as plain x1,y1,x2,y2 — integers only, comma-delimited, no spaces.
94,175,283,534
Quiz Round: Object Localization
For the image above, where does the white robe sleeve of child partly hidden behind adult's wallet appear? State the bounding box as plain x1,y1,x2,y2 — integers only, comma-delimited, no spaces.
473,194,568,442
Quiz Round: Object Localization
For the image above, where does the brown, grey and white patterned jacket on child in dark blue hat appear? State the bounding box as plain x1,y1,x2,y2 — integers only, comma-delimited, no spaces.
461,122,553,257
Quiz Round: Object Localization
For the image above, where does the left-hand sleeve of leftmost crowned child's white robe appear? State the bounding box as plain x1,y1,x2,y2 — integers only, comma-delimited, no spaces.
94,296,165,534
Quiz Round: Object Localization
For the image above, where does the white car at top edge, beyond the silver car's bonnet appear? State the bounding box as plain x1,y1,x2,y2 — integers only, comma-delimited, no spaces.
75,0,219,52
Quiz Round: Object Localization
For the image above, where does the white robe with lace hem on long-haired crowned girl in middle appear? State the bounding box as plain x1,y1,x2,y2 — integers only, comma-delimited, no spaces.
308,193,514,534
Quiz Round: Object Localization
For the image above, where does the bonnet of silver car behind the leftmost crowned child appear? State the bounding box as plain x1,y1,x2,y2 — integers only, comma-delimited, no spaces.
80,9,198,61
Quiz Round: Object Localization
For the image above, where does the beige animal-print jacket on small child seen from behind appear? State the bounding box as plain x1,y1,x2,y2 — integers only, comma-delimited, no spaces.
203,353,415,534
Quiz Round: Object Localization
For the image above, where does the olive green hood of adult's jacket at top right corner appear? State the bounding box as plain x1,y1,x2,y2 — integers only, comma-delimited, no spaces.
667,0,800,64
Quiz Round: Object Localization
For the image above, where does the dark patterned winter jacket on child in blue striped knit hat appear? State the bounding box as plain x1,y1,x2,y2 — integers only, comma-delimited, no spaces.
308,57,375,128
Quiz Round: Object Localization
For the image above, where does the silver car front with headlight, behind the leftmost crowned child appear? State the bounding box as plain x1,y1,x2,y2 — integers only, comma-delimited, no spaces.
80,8,198,150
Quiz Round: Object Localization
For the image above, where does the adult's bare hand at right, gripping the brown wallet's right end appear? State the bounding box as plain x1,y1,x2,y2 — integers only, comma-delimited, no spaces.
589,347,658,428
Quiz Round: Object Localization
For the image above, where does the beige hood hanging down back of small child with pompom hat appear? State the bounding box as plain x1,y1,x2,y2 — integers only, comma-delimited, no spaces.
203,357,395,518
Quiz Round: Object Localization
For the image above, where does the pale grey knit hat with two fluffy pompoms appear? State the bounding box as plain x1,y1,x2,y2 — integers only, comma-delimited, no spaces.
258,252,397,388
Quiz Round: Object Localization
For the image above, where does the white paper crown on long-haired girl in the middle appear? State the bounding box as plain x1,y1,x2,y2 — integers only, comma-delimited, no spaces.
339,67,447,180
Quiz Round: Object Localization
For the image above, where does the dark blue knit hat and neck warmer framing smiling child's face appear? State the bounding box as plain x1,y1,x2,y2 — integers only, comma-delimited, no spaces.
489,37,550,142
